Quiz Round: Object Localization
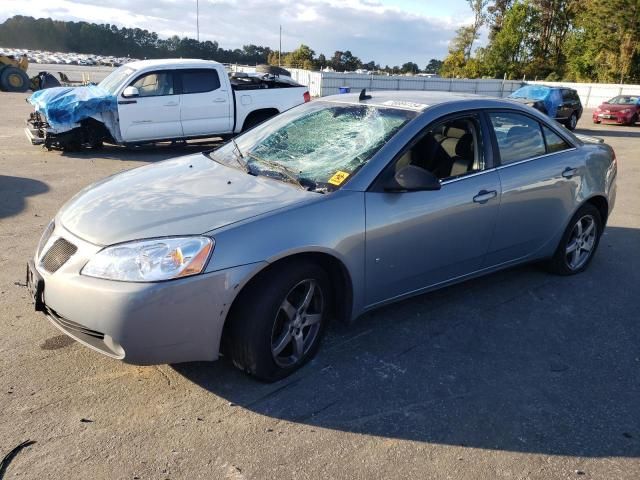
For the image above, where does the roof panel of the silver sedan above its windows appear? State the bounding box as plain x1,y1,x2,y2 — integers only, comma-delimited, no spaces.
319,90,532,112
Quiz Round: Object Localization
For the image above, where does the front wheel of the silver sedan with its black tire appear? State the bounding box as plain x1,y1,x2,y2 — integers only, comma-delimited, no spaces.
224,261,332,382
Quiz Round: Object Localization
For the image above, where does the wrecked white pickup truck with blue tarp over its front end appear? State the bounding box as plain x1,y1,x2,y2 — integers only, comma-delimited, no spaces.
26,59,310,150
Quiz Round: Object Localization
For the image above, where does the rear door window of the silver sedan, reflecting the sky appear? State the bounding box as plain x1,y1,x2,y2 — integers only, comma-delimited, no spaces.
489,112,547,165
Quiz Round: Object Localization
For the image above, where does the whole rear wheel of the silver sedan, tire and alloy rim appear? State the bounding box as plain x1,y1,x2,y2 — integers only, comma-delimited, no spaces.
549,204,603,275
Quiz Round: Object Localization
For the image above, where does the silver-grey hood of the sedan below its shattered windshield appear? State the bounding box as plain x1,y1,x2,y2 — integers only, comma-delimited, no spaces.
56,154,318,245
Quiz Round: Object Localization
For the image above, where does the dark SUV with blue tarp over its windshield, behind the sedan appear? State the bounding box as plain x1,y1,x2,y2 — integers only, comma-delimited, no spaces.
509,85,582,130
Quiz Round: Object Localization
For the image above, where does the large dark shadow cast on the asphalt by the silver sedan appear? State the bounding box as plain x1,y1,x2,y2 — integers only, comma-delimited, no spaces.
173,227,640,457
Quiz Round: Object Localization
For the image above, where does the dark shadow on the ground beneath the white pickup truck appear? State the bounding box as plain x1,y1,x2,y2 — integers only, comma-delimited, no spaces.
61,138,224,162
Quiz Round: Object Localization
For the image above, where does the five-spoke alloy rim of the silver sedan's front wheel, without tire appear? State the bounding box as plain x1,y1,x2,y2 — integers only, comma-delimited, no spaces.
271,279,324,368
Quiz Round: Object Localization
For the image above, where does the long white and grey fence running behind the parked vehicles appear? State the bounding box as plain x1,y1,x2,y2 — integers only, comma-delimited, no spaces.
234,66,640,108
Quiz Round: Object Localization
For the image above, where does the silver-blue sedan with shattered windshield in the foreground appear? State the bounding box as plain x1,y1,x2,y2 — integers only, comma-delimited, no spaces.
27,92,617,380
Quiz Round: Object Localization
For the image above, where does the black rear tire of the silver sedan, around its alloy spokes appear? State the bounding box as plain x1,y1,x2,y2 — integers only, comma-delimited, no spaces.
547,203,604,275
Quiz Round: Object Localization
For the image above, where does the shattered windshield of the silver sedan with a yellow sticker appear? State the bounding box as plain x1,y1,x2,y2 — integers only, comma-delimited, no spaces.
211,101,416,191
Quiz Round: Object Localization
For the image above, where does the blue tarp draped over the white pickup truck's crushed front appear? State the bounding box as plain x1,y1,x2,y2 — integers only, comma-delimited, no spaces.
28,85,118,127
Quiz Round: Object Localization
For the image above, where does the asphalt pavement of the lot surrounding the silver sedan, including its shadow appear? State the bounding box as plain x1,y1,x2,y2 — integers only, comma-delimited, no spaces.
0,93,640,480
